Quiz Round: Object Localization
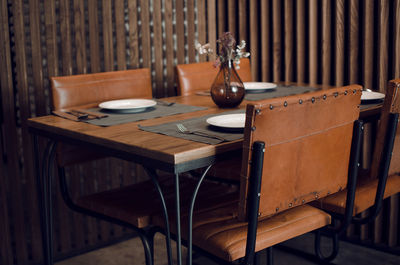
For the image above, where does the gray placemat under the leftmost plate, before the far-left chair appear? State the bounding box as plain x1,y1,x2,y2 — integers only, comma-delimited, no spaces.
85,103,207,126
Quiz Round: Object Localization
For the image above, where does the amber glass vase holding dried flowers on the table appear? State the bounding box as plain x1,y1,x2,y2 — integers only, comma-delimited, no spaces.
210,61,245,108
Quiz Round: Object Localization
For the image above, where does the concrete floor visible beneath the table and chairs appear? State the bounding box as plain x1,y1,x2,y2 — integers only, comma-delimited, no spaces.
56,234,400,265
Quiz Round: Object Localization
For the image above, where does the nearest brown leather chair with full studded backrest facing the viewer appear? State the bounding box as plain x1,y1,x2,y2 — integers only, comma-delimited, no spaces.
155,85,361,264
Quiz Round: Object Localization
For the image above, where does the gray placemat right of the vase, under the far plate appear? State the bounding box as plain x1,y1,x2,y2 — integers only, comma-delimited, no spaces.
244,85,321,101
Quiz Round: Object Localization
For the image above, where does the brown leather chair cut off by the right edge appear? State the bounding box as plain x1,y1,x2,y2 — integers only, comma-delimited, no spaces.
312,79,400,260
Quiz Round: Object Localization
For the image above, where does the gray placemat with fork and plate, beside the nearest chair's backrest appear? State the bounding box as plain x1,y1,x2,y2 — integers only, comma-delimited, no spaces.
139,110,245,144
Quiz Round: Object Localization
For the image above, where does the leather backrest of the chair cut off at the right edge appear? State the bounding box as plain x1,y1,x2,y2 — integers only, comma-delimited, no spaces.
370,79,400,175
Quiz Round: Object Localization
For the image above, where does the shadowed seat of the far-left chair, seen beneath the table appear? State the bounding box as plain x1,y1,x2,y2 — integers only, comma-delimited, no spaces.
77,175,236,228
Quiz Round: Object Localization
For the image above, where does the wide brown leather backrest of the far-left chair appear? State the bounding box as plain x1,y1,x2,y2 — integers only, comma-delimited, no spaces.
50,68,152,110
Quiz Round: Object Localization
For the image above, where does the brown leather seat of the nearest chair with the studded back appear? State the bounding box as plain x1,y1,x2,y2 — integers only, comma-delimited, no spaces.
154,202,331,261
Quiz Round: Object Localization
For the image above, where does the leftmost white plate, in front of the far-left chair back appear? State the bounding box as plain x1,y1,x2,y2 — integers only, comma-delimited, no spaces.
99,99,157,113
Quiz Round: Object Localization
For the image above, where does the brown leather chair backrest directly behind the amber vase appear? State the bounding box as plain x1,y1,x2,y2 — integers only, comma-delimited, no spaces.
176,58,252,96
